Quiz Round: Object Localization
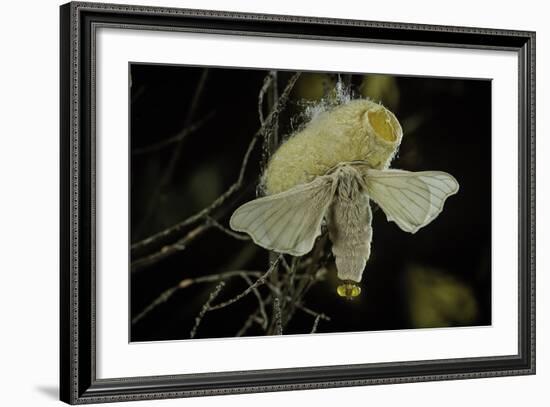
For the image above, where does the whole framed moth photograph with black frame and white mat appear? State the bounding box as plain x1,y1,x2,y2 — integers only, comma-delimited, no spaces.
60,2,535,404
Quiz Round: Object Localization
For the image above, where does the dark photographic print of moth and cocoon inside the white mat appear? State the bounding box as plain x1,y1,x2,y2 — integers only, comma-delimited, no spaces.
128,63,491,342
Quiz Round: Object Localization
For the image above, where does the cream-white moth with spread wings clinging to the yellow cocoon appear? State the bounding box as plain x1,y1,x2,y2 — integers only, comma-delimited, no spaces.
230,162,459,296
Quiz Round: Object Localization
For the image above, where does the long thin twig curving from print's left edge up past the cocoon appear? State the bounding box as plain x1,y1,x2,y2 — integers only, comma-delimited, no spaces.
131,72,300,253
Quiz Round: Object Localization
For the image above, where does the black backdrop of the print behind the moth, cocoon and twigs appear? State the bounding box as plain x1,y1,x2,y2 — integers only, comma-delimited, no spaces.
130,64,491,341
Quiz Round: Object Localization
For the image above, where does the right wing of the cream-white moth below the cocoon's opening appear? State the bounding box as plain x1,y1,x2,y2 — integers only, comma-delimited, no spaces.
365,169,459,233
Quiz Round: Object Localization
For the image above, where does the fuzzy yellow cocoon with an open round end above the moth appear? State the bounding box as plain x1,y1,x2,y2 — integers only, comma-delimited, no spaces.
264,99,403,195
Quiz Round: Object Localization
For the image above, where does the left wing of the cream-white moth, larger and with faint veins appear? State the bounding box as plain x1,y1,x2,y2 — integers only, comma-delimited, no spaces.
229,176,336,256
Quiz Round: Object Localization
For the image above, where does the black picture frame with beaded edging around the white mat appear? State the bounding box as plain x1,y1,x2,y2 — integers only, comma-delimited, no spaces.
60,2,535,404
